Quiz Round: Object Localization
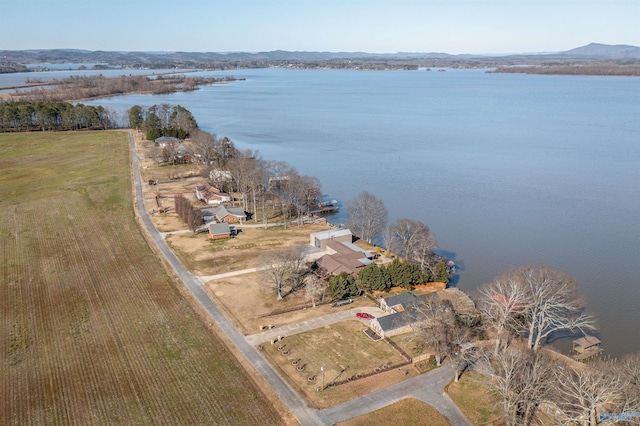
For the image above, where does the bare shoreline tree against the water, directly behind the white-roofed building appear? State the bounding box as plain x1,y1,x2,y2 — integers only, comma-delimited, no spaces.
346,191,389,244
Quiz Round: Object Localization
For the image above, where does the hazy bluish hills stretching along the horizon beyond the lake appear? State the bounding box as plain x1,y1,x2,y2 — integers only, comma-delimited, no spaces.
0,43,640,72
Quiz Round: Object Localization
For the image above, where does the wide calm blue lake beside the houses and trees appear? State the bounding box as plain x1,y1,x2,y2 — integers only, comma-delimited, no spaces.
7,69,640,356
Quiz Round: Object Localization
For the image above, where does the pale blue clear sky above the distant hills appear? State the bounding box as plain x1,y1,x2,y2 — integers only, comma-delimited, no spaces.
0,0,640,54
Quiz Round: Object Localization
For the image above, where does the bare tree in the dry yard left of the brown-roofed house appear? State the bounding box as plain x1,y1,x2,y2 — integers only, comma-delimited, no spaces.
258,246,307,300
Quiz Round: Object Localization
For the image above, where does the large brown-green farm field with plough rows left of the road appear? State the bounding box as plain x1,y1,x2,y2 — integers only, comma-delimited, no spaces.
0,132,284,425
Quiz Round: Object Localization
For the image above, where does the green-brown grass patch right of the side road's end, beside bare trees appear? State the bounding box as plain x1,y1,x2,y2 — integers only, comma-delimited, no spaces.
445,371,506,426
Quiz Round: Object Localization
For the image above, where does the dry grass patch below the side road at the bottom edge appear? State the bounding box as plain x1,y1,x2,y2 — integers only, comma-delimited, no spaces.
338,398,450,426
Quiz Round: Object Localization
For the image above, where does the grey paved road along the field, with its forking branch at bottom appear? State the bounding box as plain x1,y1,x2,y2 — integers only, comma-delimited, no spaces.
128,131,471,426
